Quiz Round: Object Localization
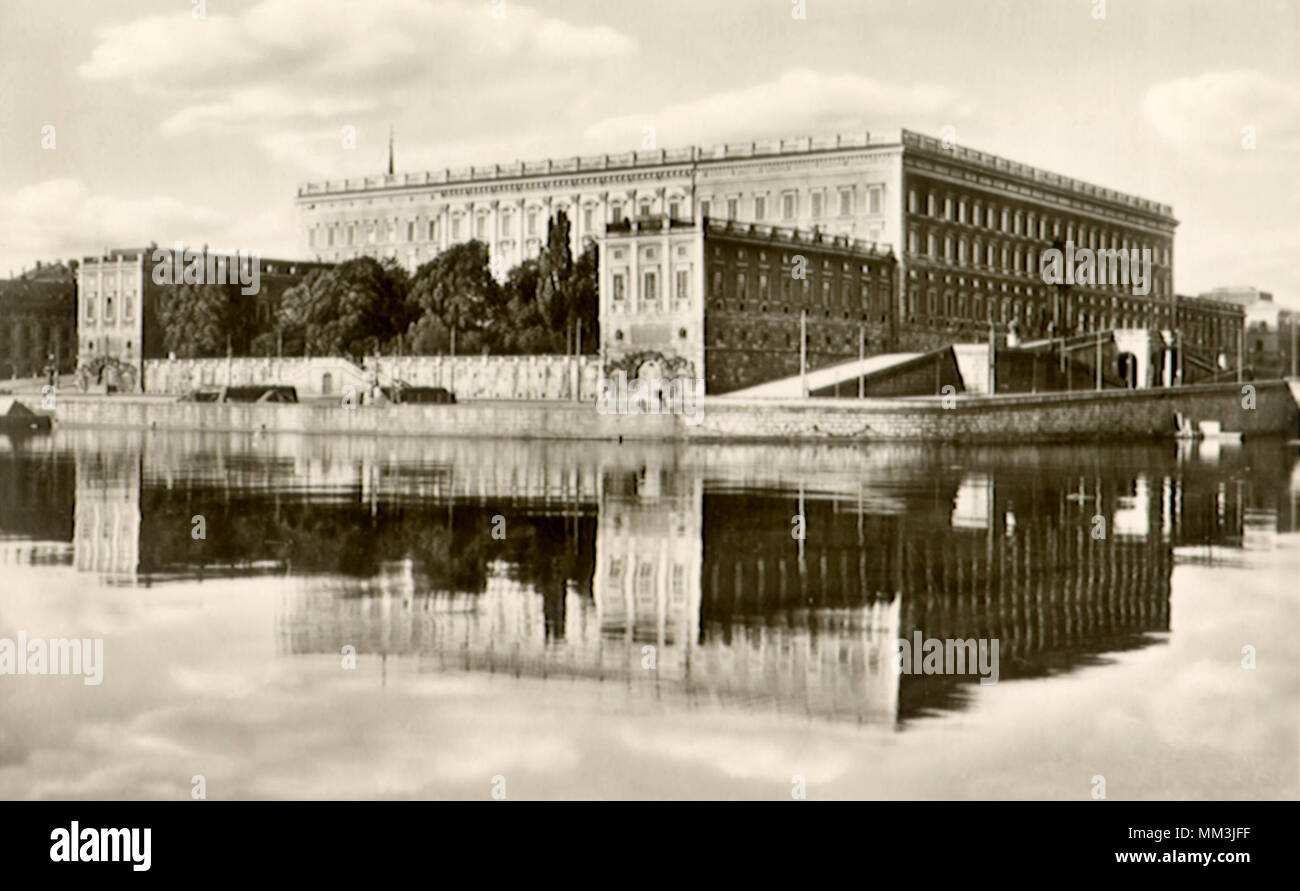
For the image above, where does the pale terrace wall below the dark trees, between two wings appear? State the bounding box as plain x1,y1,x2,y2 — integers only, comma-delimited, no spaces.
144,355,601,399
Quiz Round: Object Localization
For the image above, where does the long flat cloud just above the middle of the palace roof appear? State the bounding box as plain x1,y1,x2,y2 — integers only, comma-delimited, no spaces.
584,68,974,146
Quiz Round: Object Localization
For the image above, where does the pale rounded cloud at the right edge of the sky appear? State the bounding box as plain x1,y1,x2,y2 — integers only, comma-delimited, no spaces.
1143,72,1300,164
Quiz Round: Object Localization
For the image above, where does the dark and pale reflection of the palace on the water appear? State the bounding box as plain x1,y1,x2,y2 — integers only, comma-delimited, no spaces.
0,431,1297,727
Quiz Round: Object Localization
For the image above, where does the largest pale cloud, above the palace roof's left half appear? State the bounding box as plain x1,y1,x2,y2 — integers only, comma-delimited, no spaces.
78,0,636,174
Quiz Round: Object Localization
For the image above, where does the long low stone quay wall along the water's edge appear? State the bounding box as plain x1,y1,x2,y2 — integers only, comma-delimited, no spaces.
43,381,1300,442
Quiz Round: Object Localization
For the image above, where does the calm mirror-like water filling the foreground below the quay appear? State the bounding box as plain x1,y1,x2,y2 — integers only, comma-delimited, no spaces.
0,431,1300,800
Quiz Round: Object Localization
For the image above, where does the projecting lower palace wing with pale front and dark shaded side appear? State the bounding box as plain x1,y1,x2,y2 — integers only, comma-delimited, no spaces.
599,217,897,394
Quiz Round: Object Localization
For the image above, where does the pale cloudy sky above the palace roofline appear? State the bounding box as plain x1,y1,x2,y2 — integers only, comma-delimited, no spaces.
0,0,1300,308
